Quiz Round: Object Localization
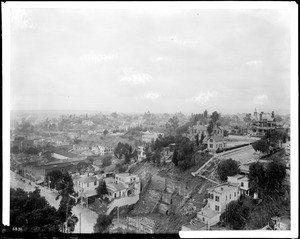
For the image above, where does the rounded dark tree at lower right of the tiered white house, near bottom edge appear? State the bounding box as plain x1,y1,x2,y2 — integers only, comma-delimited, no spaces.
221,201,250,230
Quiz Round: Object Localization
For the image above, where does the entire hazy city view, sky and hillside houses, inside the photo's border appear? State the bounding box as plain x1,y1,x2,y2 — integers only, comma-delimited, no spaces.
2,2,294,235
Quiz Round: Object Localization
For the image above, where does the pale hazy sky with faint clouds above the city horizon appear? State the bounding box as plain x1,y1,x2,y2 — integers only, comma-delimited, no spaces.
11,7,291,113
